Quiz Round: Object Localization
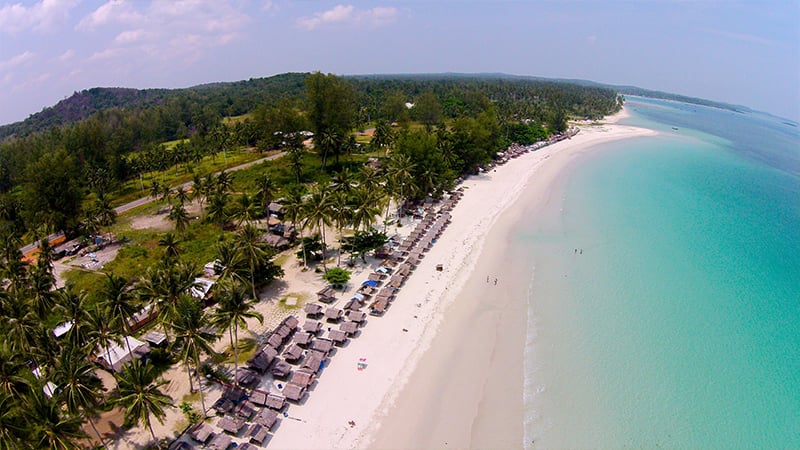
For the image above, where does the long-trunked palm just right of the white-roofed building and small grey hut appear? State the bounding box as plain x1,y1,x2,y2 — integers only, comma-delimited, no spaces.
172,295,219,418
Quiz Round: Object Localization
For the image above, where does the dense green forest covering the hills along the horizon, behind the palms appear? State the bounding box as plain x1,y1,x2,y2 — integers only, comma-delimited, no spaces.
0,73,620,235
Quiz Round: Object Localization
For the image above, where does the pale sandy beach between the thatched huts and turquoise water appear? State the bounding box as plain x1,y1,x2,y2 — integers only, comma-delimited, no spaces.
270,109,655,448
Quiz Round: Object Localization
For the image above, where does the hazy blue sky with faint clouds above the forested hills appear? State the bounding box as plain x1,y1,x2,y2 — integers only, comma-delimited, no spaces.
0,0,800,123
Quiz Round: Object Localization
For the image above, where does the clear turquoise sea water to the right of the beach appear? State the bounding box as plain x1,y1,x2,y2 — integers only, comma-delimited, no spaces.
515,98,800,449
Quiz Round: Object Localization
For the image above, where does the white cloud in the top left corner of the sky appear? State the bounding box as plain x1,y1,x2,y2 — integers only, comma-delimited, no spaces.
0,0,80,34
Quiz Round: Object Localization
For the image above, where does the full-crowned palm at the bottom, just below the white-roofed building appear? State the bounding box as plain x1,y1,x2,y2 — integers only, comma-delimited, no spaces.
113,359,172,445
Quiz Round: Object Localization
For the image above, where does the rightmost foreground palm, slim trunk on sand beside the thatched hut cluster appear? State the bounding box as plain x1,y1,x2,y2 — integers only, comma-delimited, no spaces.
212,284,264,385
